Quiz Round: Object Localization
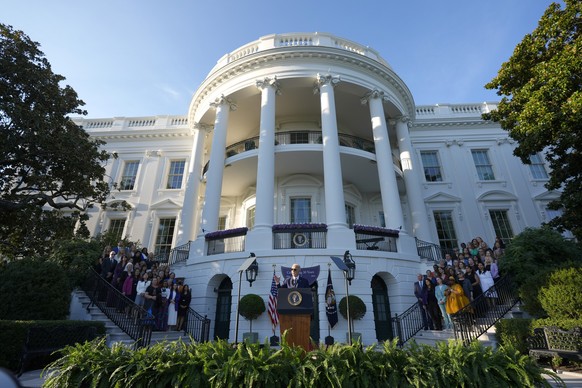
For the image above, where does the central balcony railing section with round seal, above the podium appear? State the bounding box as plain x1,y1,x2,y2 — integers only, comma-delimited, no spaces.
273,224,327,249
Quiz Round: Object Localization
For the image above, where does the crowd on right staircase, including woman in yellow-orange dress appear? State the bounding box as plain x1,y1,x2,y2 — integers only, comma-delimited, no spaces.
414,237,505,330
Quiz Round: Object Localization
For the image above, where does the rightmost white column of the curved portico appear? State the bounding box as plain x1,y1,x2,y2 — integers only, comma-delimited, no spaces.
390,116,431,241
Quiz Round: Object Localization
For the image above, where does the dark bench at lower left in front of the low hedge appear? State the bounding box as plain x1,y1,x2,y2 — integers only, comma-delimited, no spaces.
18,325,98,377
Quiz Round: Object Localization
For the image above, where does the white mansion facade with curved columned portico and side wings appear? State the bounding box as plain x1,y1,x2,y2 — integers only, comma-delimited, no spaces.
75,33,557,344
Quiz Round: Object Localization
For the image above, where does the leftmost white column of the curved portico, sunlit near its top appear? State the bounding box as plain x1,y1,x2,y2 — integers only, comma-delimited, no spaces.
176,123,210,246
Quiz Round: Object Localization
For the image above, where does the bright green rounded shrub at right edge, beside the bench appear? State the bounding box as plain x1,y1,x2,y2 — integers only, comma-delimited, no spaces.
539,268,582,320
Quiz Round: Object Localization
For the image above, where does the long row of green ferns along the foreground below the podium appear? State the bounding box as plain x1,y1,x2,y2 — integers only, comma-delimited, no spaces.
44,341,560,388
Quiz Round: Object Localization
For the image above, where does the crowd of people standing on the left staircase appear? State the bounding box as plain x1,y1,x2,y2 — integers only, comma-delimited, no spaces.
95,241,192,331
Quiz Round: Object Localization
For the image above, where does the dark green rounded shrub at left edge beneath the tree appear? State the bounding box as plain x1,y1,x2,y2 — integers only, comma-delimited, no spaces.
0,259,72,320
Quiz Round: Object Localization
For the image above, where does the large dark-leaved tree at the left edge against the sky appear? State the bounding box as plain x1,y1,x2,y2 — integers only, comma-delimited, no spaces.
0,24,110,257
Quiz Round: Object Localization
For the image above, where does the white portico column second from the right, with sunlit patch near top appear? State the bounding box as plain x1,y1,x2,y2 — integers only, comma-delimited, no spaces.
362,90,404,232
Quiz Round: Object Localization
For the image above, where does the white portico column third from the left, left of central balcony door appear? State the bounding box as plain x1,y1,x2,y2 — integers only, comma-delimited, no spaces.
255,78,280,231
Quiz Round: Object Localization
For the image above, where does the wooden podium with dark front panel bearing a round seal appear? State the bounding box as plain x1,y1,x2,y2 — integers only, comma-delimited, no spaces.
277,288,313,351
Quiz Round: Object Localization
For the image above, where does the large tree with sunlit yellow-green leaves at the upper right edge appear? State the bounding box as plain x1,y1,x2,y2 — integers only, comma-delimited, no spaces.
484,0,582,239
